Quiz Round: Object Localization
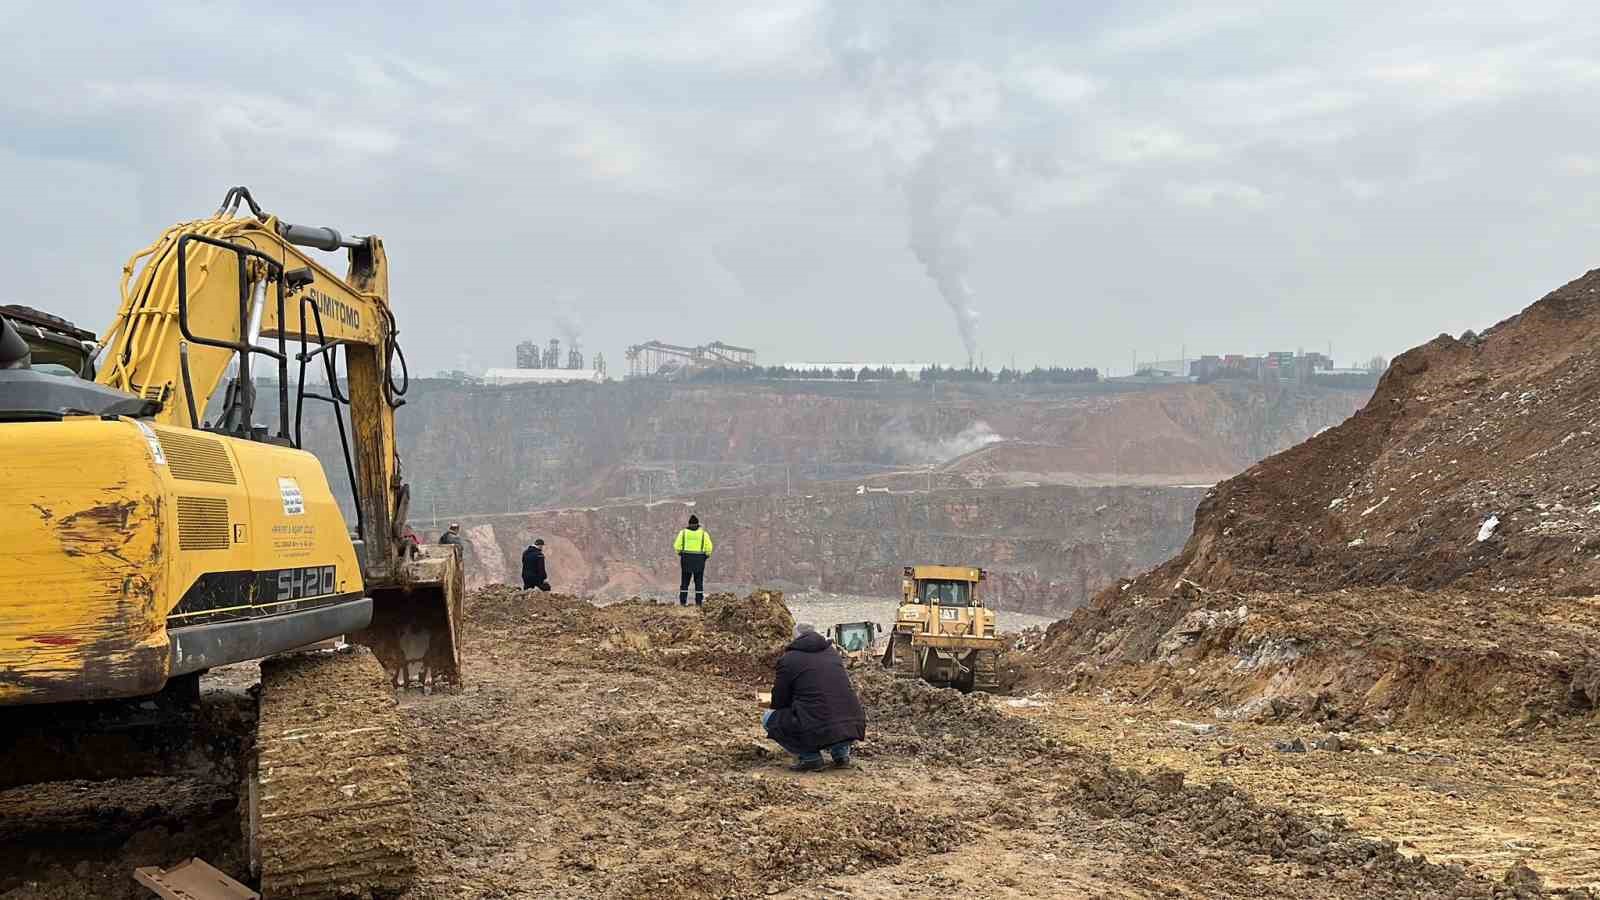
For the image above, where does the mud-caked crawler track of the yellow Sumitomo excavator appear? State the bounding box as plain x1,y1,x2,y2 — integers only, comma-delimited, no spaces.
246,649,416,897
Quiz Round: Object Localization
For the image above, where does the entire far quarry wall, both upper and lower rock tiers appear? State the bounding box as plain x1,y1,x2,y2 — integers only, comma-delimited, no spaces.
262,374,1366,615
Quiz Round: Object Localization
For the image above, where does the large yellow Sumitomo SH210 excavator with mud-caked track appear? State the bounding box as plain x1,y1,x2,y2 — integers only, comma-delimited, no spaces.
0,187,462,897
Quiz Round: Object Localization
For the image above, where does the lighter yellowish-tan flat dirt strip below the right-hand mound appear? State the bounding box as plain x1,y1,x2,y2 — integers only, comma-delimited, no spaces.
1002,692,1600,889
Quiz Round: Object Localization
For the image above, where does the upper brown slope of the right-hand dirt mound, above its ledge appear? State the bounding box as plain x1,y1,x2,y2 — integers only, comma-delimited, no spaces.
1126,271,1600,596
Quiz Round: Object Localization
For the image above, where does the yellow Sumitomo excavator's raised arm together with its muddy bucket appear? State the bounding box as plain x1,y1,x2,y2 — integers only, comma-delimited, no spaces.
96,187,462,682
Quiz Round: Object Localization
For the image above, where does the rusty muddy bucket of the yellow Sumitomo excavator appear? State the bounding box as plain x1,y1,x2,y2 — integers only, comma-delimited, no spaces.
350,546,466,690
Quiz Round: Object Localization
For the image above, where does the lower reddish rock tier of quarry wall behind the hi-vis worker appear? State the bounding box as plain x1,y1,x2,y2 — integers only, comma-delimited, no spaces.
432,485,1205,615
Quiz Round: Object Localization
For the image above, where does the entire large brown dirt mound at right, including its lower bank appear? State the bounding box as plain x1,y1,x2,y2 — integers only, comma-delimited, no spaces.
1035,271,1600,717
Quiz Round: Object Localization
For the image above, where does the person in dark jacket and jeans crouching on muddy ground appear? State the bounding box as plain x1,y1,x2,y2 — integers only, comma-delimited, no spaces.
762,625,867,772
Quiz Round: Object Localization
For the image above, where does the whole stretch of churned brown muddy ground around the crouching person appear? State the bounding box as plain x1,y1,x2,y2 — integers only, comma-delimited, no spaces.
0,591,1597,900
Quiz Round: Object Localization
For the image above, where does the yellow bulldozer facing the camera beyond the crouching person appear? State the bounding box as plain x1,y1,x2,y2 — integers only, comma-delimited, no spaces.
883,565,1000,690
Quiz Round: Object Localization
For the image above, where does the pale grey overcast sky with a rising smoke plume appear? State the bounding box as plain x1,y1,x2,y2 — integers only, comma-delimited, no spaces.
0,0,1600,375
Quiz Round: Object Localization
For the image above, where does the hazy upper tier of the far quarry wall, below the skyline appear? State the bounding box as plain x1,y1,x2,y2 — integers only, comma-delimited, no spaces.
284,381,1366,519
